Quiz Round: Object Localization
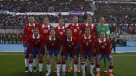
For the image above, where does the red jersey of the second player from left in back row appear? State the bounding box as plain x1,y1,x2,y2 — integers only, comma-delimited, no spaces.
41,24,53,39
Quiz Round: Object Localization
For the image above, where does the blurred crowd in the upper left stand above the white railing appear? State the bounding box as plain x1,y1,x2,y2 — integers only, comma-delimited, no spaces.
0,0,92,12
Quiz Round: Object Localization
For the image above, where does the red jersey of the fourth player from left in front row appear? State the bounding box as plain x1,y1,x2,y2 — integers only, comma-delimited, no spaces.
80,34,95,56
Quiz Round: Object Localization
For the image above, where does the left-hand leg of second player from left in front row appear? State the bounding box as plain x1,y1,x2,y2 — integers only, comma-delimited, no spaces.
46,50,53,76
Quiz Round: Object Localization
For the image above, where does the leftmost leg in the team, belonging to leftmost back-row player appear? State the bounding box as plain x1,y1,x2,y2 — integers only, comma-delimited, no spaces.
24,45,29,72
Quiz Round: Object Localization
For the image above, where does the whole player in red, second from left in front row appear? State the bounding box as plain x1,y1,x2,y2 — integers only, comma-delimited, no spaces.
45,28,61,76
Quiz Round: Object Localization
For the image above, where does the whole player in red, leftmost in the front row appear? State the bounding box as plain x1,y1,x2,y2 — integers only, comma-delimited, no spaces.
27,27,44,76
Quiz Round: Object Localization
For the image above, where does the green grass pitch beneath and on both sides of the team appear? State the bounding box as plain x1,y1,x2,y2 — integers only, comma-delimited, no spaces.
0,52,136,76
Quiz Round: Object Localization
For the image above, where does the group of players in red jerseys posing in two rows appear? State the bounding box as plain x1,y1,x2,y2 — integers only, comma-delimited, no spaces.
23,17,113,76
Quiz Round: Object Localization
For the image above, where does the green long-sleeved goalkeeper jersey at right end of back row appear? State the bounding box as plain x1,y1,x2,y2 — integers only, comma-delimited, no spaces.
97,24,110,37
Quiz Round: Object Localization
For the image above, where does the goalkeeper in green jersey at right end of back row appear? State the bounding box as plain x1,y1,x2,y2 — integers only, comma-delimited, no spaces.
97,17,110,73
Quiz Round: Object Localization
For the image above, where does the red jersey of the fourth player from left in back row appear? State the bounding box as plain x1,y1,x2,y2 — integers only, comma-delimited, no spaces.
67,23,83,38
